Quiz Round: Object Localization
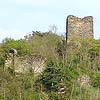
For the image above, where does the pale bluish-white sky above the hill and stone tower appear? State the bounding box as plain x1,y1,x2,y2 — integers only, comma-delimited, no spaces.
0,0,100,42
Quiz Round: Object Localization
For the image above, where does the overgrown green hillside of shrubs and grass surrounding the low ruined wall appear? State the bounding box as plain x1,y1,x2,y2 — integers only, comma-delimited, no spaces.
0,32,100,100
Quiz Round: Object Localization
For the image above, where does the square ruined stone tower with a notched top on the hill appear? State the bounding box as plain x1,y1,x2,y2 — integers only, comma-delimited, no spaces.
66,15,93,39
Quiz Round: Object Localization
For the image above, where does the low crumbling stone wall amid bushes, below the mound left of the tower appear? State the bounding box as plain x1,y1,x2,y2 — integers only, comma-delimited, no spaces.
5,55,46,74
